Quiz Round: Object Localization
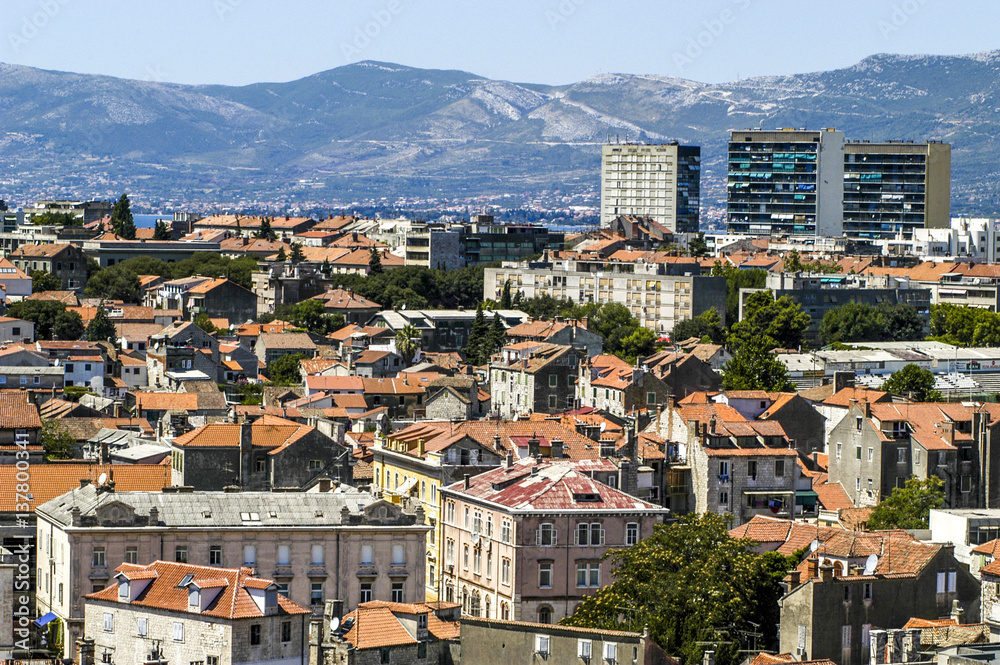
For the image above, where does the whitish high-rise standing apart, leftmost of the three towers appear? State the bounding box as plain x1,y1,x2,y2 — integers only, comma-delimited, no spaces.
601,142,701,233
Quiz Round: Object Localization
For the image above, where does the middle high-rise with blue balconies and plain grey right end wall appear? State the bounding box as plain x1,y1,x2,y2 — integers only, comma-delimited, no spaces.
726,129,844,236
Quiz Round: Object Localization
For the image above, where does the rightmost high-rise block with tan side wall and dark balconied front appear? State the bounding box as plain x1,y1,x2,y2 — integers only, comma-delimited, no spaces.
844,141,951,239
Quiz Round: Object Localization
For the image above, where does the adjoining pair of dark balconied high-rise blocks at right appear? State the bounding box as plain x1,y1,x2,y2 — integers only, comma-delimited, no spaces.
726,129,951,239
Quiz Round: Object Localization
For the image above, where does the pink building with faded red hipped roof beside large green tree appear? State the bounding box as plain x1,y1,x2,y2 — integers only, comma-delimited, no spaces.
441,457,669,623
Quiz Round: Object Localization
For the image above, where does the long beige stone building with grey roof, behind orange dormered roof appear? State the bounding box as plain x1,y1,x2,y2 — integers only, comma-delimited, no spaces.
35,485,429,662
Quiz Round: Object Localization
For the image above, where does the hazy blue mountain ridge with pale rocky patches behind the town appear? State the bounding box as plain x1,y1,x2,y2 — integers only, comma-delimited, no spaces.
0,51,1000,214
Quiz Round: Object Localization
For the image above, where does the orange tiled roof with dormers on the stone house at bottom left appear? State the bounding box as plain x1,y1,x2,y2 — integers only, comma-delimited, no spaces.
85,561,310,619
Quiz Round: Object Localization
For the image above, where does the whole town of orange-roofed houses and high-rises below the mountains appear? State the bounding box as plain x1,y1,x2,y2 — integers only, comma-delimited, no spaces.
0,129,1000,665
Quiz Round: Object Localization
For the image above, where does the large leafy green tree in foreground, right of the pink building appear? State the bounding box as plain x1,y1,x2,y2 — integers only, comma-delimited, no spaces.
560,513,796,665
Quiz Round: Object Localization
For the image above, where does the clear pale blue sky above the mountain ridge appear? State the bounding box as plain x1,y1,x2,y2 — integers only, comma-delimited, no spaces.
0,0,1000,85
